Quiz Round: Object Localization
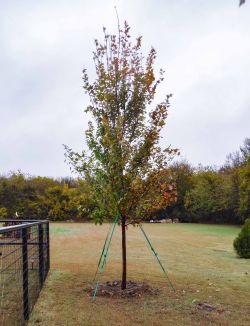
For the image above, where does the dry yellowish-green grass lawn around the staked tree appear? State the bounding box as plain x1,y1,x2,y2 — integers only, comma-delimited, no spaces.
29,223,250,326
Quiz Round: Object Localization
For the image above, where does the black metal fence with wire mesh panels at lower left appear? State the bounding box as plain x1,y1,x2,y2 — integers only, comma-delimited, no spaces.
0,220,50,326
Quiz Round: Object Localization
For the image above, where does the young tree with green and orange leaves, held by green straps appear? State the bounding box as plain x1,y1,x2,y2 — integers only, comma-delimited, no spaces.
66,22,178,289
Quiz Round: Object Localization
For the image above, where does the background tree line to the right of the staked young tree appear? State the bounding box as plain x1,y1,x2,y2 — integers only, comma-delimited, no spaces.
158,138,250,224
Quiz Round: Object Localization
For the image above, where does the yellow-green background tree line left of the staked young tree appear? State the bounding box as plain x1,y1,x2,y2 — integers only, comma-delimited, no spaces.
0,171,91,221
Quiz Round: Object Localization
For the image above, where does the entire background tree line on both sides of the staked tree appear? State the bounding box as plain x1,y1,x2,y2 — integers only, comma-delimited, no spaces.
0,138,250,224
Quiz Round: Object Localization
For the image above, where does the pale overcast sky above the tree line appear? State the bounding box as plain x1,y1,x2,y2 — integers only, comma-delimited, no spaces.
0,0,250,177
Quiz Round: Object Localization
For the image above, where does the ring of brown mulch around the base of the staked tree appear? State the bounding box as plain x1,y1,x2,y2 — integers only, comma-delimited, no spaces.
88,281,160,298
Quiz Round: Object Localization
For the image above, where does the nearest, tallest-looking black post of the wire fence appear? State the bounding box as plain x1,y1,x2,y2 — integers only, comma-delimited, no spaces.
22,228,29,320
